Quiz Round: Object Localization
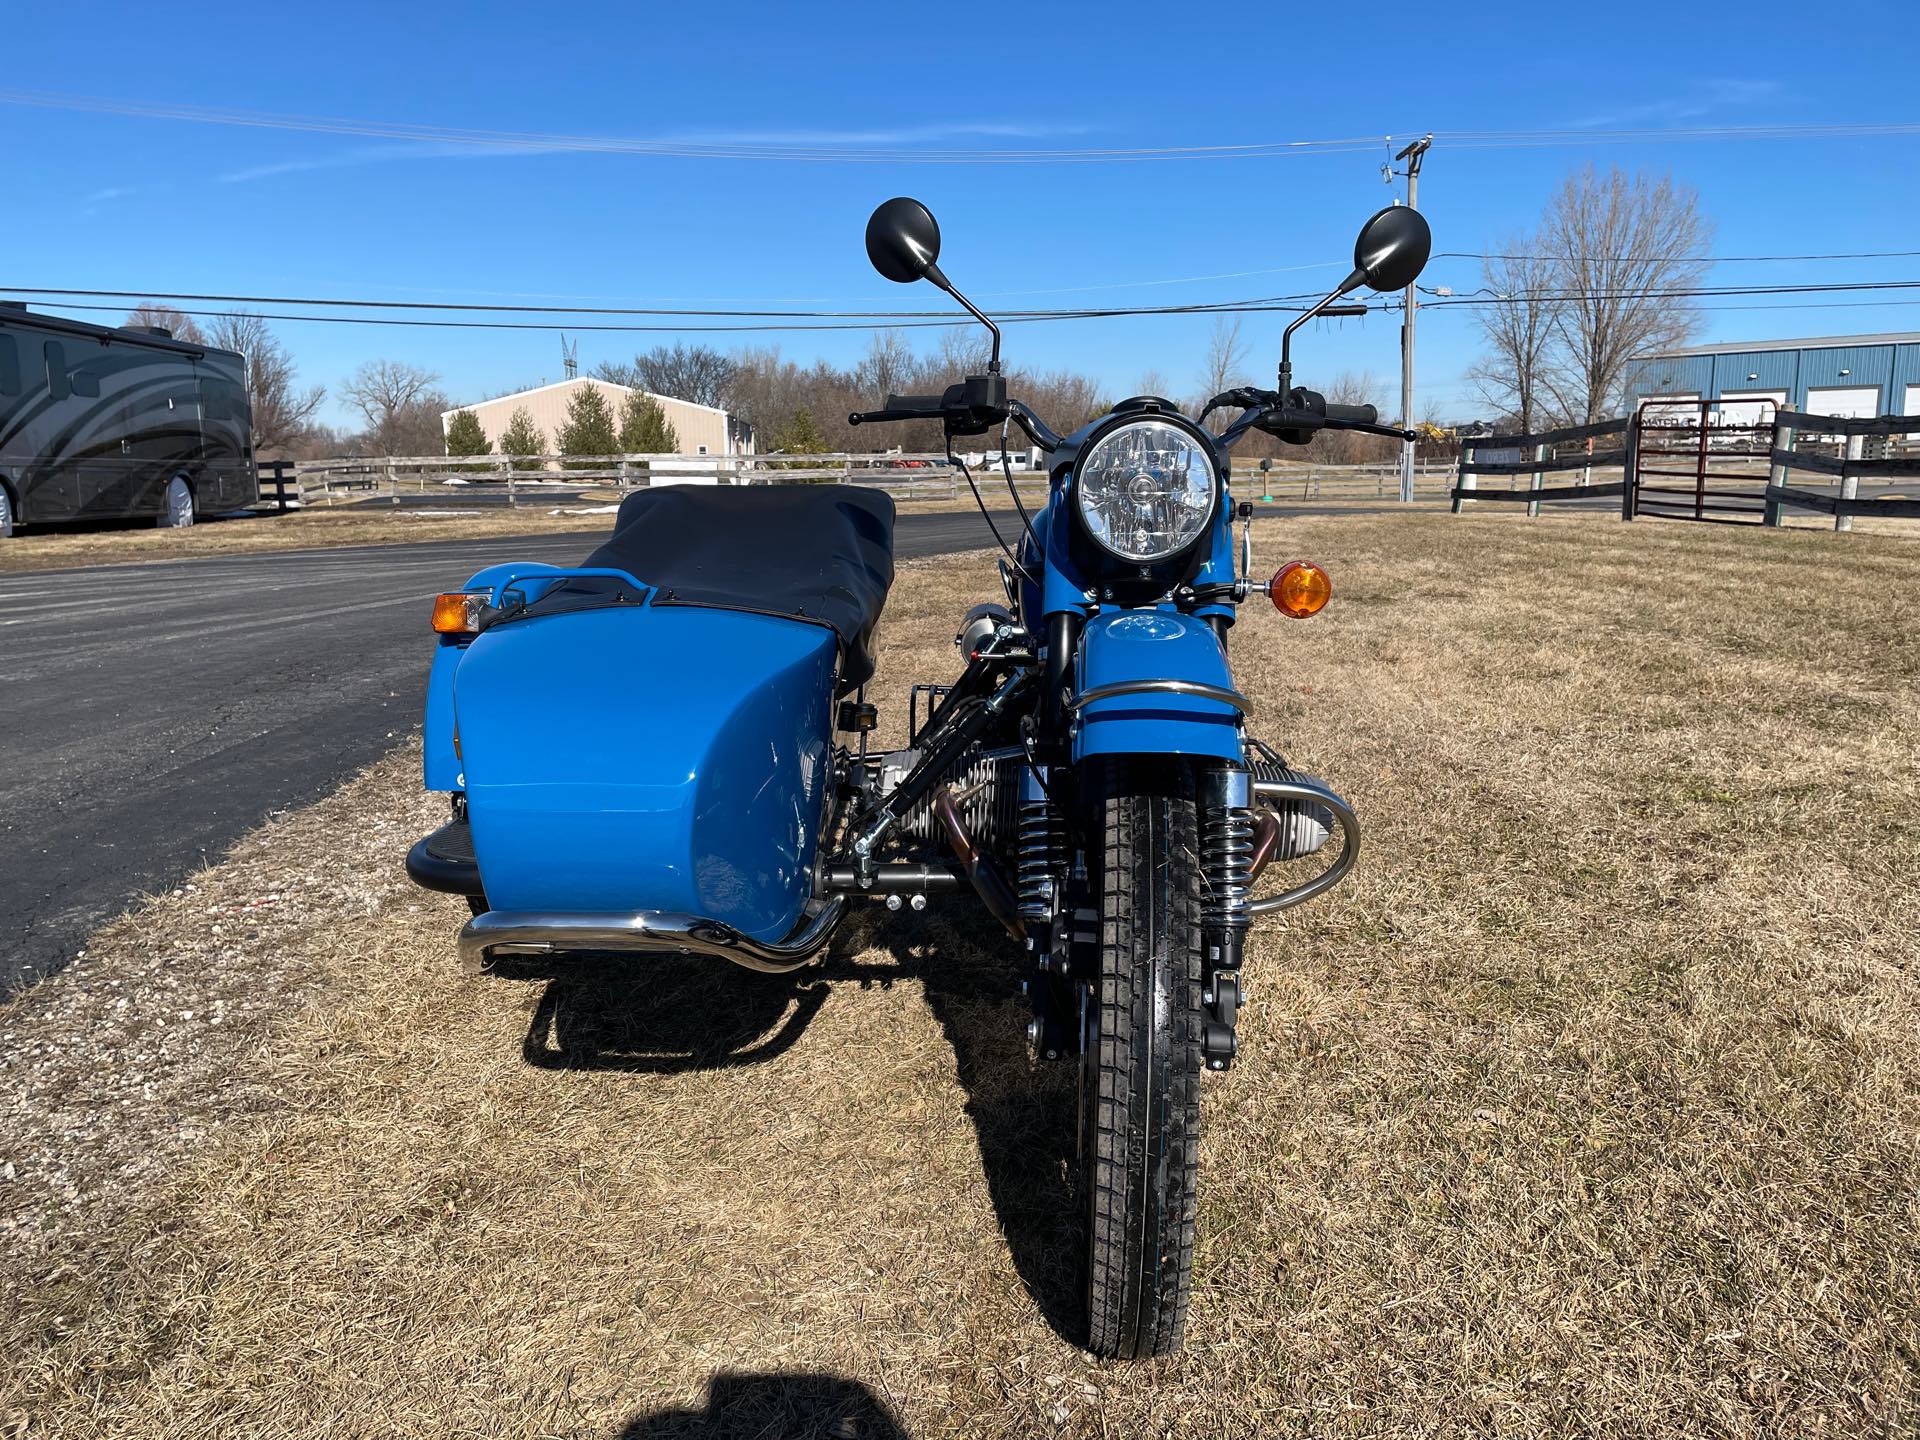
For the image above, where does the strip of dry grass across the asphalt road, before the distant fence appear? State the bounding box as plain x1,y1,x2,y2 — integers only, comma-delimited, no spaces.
0,501,612,574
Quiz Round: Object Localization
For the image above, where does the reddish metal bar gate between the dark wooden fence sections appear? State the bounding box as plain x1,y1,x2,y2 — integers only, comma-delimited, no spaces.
1632,399,1776,524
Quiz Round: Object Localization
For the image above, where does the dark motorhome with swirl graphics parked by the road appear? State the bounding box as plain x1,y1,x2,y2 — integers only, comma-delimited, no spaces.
0,303,259,538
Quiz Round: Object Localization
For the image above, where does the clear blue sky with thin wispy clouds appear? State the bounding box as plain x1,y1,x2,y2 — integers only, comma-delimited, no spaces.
0,0,1920,422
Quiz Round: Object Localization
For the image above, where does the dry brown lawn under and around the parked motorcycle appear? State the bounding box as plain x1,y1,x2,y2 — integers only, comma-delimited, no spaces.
0,516,1920,1436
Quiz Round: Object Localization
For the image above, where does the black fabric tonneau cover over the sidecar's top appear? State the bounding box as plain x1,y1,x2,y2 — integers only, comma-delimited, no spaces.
586,486,893,691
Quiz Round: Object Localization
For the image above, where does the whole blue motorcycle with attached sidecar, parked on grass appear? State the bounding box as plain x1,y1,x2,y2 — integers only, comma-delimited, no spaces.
407,198,1430,1357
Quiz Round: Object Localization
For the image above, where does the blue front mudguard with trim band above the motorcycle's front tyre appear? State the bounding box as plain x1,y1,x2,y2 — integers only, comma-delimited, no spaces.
1073,611,1244,760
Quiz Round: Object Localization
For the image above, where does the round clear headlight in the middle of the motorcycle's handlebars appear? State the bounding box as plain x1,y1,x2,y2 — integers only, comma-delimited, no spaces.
1073,420,1217,563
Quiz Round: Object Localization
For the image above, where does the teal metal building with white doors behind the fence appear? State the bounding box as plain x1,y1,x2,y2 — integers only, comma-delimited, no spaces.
1632,330,1920,424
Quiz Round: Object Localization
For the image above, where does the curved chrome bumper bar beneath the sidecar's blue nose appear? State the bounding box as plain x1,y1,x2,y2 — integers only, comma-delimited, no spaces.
461,895,847,975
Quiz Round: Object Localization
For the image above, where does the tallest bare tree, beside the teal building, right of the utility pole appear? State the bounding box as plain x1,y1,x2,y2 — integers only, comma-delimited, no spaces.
1542,165,1713,422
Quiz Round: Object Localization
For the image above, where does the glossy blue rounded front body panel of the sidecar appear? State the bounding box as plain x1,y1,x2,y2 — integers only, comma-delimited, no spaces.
453,605,837,943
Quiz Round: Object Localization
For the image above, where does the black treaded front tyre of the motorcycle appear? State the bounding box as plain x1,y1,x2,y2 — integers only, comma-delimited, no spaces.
1081,795,1202,1359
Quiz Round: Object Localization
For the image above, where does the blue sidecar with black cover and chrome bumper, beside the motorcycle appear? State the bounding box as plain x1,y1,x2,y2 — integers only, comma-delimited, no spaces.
407,486,893,970
